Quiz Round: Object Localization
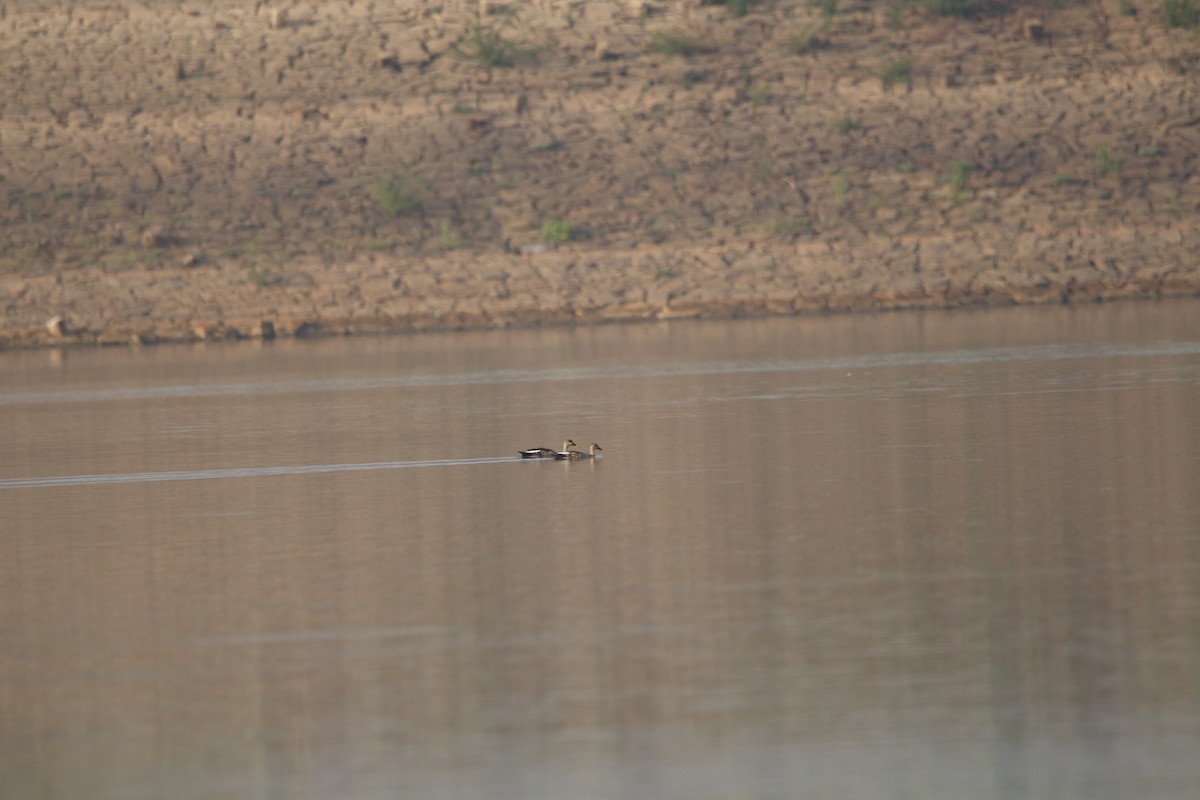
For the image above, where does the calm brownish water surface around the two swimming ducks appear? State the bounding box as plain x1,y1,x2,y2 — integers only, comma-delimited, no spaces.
0,303,1200,800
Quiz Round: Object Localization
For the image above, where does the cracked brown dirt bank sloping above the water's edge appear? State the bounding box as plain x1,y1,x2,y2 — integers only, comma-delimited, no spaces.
0,0,1200,348
